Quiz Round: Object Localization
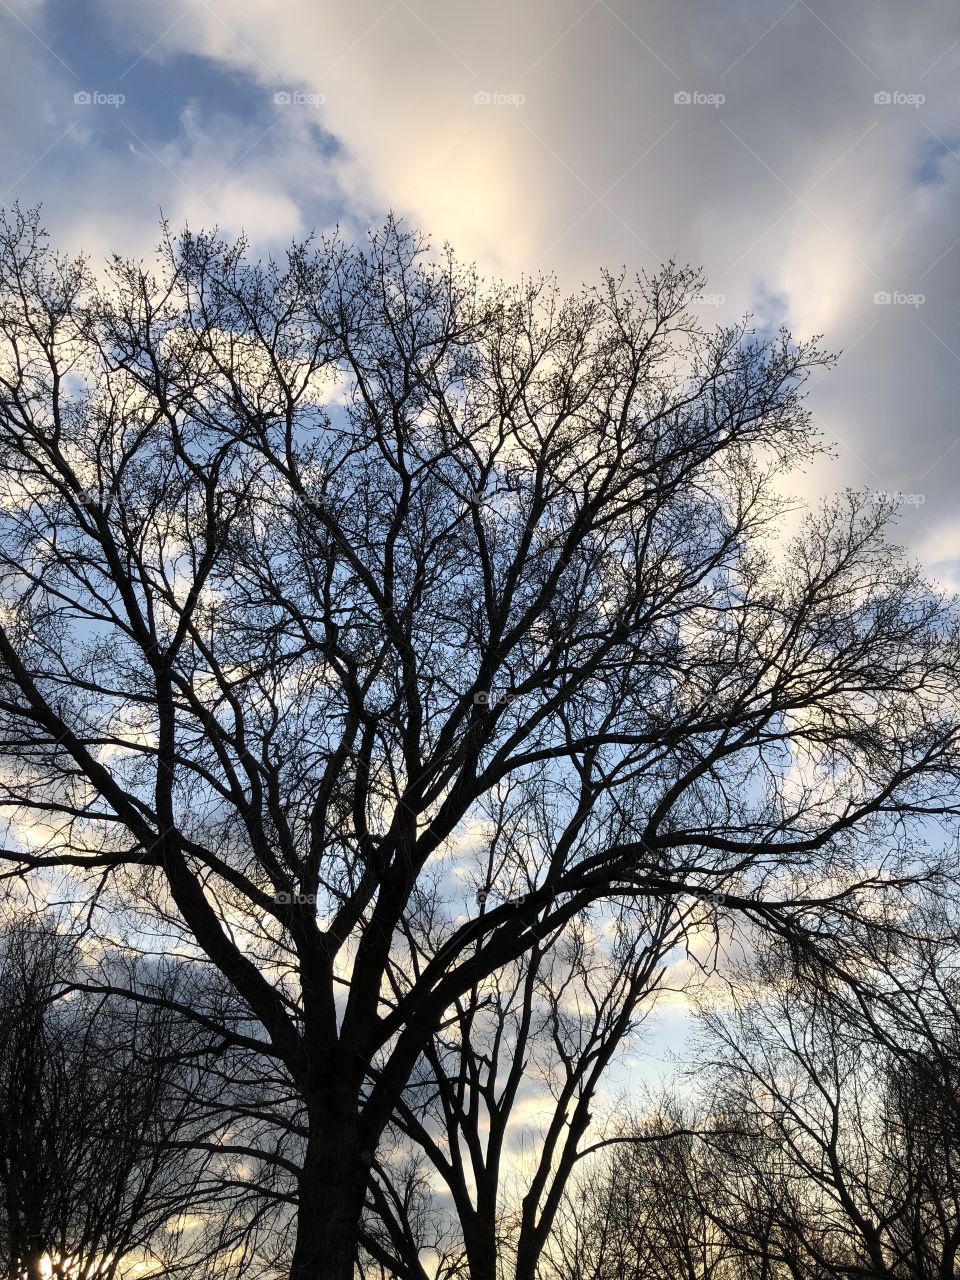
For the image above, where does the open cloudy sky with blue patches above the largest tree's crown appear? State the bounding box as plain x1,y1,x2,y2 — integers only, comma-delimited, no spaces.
0,0,960,588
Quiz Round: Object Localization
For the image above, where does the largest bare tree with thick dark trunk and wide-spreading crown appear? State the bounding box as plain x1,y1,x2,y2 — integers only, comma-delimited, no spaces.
0,202,957,1280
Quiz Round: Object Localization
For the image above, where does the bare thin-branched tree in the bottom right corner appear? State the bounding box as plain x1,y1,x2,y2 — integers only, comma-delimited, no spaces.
705,942,960,1280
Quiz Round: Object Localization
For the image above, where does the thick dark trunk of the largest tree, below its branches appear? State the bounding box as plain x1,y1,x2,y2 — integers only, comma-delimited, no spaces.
291,1098,372,1280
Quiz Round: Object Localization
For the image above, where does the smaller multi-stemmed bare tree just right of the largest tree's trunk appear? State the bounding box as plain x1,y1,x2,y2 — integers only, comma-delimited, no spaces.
371,888,682,1280
